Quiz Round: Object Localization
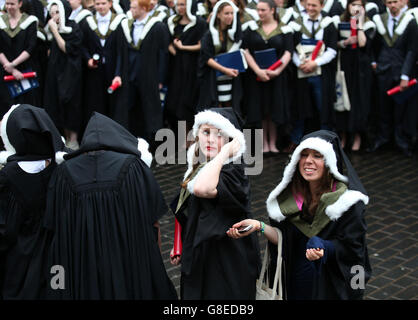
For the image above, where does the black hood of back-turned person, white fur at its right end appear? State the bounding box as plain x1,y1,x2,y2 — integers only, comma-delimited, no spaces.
64,112,152,167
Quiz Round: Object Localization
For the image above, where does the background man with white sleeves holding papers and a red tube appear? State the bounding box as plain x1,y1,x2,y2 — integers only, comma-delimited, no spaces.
290,0,338,144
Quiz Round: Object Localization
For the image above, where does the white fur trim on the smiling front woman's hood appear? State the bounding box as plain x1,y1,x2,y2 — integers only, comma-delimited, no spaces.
266,137,369,222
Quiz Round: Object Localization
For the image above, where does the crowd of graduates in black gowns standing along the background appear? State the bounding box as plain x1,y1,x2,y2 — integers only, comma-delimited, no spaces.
0,0,418,155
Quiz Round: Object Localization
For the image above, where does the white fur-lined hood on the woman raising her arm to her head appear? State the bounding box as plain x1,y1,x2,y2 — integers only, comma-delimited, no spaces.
183,108,246,193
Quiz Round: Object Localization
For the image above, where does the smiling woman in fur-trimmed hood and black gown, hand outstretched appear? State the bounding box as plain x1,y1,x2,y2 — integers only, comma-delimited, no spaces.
228,130,371,300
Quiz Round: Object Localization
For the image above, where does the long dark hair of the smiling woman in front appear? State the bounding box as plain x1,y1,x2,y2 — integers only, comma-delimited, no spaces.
290,164,334,216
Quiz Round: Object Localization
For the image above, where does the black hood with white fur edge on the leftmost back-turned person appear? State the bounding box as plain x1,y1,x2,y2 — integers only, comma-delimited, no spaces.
0,104,68,164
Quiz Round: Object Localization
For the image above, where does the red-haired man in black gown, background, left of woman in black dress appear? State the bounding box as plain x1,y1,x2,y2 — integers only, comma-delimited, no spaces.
122,0,169,149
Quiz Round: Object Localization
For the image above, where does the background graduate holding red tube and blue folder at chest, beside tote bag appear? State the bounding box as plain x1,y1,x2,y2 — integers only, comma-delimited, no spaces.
333,0,376,151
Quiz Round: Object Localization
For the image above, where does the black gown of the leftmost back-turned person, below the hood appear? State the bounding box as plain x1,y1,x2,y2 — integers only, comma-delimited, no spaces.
0,161,56,300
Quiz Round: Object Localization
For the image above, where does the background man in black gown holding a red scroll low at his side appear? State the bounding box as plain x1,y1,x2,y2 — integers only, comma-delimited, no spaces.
83,0,128,128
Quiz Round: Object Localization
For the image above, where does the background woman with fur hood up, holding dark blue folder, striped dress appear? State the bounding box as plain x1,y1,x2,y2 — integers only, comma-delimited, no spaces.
197,0,242,113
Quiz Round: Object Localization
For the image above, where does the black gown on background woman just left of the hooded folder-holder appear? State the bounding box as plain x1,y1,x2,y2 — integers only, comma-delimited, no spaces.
164,16,207,124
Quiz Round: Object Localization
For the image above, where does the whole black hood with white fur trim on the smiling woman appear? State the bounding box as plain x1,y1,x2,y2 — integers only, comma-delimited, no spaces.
266,130,369,222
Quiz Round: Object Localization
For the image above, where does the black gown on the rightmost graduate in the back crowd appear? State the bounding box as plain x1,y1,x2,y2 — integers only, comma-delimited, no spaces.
373,12,418,139
